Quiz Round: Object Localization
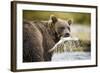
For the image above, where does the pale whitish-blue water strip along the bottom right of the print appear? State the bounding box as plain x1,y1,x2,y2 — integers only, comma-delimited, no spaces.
52,52,91,61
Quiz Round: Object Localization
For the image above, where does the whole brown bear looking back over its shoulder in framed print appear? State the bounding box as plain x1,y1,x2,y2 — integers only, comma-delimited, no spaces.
23,15,72,62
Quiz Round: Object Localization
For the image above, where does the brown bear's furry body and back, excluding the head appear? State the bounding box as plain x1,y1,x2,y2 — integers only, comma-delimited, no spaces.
23,21,57,62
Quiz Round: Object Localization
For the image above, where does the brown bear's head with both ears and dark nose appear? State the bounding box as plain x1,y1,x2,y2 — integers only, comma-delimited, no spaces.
49,15,72,39
